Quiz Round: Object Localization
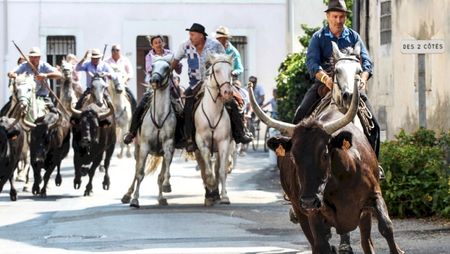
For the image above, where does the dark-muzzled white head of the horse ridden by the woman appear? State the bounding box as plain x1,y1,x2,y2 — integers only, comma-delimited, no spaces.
150,54,173,89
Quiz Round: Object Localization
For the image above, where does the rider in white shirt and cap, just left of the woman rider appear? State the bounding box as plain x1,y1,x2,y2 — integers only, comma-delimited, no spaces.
106,44,137,108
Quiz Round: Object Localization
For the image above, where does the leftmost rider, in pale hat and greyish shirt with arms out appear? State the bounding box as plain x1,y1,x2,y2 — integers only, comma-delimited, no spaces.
8,47,62,113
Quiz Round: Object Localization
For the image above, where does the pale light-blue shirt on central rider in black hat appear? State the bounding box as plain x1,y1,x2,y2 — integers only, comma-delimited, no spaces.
175,38,225,87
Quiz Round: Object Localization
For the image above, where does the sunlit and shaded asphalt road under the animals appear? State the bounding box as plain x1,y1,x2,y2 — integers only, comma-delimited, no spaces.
0,148,450,254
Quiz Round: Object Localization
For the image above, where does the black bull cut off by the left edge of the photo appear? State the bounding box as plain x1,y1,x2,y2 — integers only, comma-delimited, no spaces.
0,117,24,201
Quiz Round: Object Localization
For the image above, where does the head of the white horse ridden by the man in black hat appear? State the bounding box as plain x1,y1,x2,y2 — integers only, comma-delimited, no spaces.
207,54,233,101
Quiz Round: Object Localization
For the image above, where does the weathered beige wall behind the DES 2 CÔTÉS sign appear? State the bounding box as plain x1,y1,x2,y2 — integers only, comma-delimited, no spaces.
369,0,450,138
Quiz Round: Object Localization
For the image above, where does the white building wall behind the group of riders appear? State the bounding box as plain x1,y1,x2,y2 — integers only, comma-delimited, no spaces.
0,0,296,104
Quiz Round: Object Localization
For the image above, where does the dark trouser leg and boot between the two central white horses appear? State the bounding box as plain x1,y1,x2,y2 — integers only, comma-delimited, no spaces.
184,88,196,152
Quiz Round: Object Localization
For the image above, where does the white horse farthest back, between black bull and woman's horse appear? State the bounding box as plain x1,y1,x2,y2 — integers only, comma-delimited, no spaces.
108,65,133,158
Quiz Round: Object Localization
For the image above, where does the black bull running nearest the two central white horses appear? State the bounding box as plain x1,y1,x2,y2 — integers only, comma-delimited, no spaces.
71,103,116,196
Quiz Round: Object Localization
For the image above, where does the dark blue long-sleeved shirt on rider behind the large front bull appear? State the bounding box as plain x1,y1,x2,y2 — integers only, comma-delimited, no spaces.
306,26,373,79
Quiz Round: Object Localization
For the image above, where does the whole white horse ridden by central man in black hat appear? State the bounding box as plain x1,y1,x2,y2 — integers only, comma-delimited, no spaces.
194,54,234,206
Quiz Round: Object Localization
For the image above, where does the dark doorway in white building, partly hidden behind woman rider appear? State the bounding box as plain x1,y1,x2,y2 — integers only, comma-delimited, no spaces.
136,35,169,101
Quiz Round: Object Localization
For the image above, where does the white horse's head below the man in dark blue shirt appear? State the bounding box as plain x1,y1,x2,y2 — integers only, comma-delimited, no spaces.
331,42,362,109
